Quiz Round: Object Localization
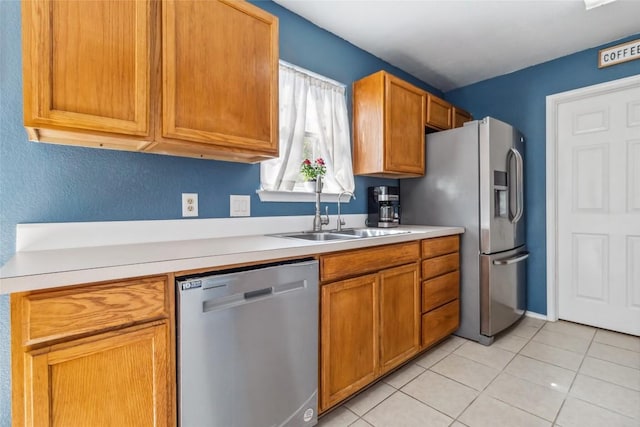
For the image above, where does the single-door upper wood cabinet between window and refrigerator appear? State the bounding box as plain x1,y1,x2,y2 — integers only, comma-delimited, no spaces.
353,71,426,178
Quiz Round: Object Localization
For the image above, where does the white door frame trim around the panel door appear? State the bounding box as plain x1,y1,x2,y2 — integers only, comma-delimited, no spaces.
546,75,640,321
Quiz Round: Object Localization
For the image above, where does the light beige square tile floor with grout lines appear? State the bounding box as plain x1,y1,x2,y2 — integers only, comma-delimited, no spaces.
318,317,640,427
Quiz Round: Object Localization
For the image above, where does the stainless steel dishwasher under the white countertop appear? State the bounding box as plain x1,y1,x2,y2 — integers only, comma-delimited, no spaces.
176,260,318,427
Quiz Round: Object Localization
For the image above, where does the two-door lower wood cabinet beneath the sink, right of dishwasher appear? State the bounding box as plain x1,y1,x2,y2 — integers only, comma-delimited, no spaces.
320,242,420,412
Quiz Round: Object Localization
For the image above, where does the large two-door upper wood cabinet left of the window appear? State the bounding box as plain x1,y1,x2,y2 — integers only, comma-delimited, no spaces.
22,0,279,162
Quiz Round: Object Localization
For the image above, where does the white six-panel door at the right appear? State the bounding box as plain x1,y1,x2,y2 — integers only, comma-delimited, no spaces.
557,85,640,335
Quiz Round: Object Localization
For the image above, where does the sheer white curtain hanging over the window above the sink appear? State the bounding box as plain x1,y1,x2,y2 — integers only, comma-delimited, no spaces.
260,63,355,193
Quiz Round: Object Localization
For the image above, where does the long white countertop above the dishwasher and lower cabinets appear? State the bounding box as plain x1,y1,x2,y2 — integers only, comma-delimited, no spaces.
0,217,464,293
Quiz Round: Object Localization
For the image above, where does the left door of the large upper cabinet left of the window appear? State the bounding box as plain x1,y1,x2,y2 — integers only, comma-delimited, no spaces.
22,0,152,136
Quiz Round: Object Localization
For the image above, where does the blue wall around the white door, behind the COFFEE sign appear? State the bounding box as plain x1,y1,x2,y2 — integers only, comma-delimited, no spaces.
445,34,640,314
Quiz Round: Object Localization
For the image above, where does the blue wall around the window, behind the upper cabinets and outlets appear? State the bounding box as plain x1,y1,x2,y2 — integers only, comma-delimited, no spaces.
0,0,442,426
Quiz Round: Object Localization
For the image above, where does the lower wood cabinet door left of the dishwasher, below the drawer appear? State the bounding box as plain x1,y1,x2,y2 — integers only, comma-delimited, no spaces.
24,321,173,426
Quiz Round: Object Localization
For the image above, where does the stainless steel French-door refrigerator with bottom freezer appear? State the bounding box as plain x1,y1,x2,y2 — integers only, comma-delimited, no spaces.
400,117,529,345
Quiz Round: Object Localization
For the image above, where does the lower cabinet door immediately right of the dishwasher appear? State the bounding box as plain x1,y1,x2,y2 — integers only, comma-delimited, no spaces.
320,274,378,411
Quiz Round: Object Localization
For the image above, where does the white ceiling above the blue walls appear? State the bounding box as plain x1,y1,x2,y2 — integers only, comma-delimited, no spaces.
274,0,640,92
